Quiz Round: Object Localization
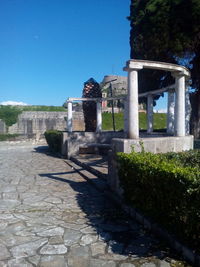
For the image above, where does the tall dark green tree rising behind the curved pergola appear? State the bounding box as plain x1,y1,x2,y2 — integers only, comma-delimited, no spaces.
129,0,200,138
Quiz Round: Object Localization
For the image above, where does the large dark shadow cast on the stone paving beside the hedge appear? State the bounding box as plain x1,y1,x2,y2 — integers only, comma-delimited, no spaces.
40,170,181,260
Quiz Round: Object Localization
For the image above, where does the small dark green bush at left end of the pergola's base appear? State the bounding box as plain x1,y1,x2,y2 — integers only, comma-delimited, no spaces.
44,130,62,152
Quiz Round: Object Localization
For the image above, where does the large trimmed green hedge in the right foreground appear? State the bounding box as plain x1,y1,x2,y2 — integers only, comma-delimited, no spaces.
117,151,200,252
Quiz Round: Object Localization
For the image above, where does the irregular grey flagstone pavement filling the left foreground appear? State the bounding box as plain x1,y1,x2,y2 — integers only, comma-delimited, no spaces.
0,142,190,267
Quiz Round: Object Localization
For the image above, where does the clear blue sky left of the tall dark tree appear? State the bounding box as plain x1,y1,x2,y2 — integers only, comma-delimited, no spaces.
0,0,130,105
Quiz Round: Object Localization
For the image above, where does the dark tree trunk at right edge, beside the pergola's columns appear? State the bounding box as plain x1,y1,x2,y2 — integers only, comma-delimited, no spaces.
190,90,200,139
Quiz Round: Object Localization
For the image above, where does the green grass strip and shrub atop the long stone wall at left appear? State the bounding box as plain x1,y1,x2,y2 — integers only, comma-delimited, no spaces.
0,105,66,126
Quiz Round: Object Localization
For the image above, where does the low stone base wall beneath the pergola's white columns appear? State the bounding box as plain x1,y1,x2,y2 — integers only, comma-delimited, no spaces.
62,131,194,159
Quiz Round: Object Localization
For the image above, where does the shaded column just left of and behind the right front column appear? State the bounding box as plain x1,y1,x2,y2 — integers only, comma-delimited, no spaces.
167,89,175,134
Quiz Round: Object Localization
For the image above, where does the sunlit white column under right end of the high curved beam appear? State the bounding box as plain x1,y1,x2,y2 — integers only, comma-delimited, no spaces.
175,73,185,136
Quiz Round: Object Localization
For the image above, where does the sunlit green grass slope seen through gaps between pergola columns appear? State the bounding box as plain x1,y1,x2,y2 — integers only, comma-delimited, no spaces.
103,113,167,130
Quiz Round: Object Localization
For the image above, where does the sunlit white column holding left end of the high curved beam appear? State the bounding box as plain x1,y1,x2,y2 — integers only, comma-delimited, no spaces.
128,69,139,139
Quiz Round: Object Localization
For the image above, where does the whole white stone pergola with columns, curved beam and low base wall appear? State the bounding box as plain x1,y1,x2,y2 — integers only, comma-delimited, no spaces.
63,60,193,158
